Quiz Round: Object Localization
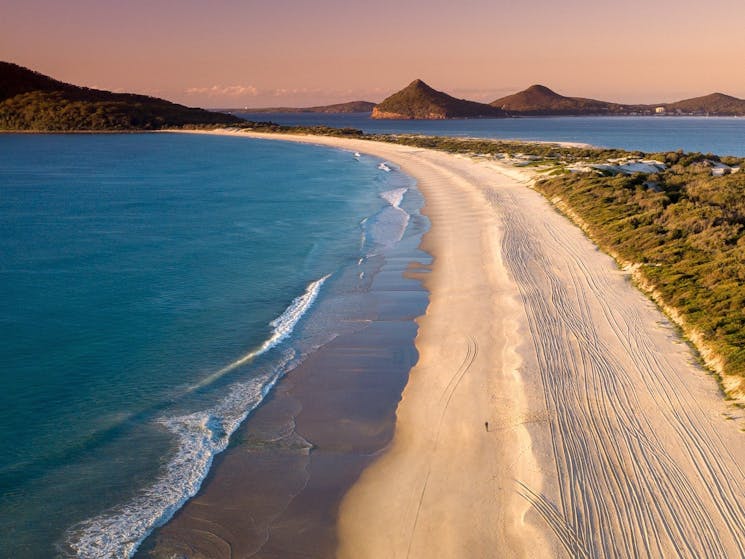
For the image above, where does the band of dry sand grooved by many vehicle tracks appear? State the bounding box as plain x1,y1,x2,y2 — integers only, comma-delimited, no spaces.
476,180,745,558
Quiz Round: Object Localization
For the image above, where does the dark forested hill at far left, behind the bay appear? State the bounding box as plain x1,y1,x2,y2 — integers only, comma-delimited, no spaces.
0,61,238,132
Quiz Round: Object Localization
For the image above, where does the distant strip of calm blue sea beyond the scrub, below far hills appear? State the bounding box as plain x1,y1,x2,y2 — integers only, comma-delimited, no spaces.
237,113,745,156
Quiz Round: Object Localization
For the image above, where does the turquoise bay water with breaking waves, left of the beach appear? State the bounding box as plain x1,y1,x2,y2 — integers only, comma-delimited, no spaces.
0,134,418,557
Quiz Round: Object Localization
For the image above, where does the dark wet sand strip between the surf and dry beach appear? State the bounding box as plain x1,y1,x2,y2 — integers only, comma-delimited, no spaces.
135,132,431,558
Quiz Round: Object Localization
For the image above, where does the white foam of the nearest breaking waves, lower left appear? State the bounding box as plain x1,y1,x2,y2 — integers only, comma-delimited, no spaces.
67,276,329,559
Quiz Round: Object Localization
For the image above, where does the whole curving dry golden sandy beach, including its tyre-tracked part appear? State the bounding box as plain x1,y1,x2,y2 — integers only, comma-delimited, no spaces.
150,132,745,559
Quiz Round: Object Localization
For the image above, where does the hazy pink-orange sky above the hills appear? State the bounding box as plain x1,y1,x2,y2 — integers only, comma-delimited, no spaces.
0,0,745,108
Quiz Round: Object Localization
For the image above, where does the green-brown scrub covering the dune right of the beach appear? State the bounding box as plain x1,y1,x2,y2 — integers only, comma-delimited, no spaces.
535,152,745,399
